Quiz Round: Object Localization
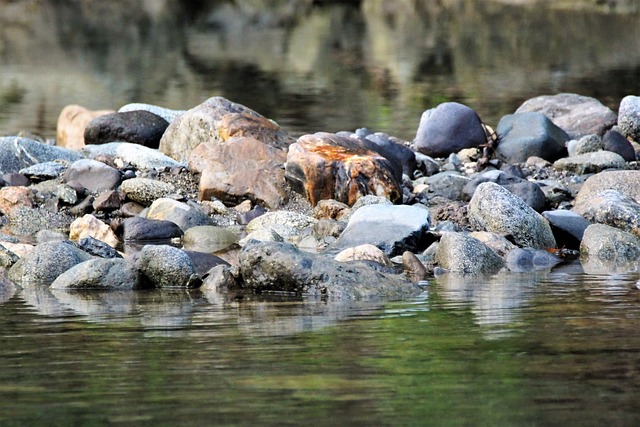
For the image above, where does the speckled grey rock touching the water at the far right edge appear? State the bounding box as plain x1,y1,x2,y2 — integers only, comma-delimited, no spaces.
580,224,640,263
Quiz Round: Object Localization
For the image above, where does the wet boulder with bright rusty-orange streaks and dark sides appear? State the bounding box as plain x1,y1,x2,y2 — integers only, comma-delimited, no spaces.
285,132,402,206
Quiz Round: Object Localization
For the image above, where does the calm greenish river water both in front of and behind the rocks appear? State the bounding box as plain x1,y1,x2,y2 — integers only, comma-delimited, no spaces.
0,0,640,426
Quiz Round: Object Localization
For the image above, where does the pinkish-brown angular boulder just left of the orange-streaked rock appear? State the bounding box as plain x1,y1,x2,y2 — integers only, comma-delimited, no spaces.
189,138,288,209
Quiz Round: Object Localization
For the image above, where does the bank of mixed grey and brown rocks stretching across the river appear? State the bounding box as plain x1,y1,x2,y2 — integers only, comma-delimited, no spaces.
0,94,640,299
